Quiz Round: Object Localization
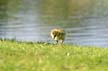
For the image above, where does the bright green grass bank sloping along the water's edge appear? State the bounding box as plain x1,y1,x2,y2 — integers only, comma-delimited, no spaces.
0,41,108,71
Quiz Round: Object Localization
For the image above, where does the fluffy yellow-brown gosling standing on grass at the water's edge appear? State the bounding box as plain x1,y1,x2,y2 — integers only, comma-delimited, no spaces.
50,28,66,43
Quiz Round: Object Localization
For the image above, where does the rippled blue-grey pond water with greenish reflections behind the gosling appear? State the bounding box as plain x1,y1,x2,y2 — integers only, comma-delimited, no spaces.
0,0,108,47
